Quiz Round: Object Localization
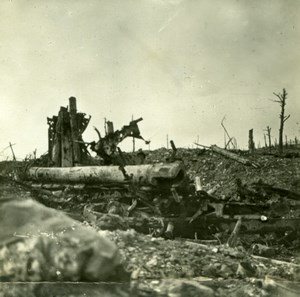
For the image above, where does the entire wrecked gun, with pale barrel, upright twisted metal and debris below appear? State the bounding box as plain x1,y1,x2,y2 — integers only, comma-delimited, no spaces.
23,97,299,238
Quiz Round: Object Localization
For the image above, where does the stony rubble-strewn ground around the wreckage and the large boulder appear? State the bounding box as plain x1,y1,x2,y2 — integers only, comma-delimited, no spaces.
0,149,300,297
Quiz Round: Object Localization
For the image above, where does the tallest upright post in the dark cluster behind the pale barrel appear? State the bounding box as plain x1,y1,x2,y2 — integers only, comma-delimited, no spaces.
69,97,81,166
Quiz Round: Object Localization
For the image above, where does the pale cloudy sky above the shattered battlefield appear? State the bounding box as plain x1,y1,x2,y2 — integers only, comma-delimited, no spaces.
0,0,300,160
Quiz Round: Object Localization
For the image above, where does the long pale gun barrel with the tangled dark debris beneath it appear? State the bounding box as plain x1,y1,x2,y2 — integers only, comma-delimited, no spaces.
21,157,299,238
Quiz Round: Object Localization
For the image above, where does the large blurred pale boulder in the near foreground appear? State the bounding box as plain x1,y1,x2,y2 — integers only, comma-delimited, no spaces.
0,200,128,281
